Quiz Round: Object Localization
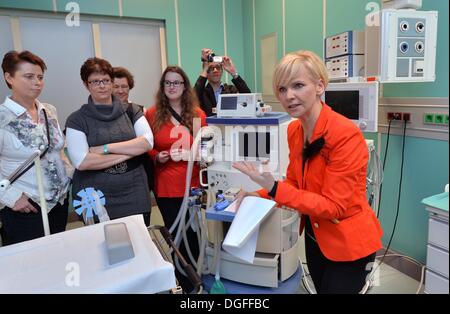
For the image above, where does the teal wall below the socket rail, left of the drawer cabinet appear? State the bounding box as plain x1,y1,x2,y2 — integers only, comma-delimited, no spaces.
380,135,449,263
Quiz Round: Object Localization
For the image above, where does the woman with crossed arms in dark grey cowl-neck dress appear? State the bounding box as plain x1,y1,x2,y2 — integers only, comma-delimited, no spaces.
66,58,153,224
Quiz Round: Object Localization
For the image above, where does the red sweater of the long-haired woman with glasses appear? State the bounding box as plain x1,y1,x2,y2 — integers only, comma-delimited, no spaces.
145,106,206,197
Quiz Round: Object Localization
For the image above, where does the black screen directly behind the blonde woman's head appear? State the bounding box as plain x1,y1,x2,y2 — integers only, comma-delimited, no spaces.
325,90,359,120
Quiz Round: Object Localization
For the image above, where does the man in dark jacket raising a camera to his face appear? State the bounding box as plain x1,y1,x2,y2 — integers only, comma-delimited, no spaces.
194,48,251,117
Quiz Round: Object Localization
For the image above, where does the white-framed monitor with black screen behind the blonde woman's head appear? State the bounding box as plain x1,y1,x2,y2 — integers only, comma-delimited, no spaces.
323,82,378,132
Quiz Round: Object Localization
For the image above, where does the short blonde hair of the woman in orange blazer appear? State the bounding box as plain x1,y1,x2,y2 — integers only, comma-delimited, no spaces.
273,50,328,97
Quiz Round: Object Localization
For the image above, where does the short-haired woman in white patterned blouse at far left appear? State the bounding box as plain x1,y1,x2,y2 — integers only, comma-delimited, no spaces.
0,51,70,245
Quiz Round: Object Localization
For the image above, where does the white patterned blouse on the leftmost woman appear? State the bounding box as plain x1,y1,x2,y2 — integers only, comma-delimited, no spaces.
0,97,72,211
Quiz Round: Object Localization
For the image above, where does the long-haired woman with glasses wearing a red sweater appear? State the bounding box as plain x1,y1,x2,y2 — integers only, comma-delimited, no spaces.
145,66,206,292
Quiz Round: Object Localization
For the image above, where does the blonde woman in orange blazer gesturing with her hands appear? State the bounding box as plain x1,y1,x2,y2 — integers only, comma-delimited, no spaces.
233,51,382,293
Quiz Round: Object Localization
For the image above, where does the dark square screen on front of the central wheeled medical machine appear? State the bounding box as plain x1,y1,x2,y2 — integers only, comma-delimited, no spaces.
238,132,270,158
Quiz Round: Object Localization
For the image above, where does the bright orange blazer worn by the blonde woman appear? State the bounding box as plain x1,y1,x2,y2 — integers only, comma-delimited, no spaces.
258,103,383,261
